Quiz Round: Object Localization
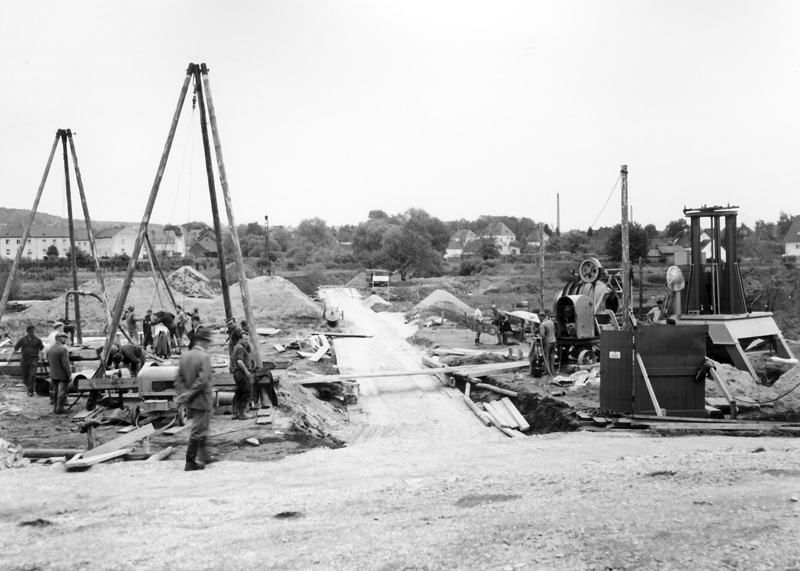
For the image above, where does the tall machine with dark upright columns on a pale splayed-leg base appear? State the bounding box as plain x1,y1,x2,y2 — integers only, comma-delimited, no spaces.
668,206,794,378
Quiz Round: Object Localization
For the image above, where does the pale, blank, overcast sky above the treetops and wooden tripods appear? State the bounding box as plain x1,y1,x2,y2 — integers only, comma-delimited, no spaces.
0,0,800,235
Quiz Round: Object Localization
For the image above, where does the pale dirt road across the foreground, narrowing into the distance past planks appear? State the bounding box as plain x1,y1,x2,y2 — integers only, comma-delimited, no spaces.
0,292,800,571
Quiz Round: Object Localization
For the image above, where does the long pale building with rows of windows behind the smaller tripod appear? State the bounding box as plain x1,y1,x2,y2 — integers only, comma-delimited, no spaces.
0,224,91,260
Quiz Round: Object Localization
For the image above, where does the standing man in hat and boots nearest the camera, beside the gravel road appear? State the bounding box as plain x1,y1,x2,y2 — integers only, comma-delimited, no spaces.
175,327,215,472
